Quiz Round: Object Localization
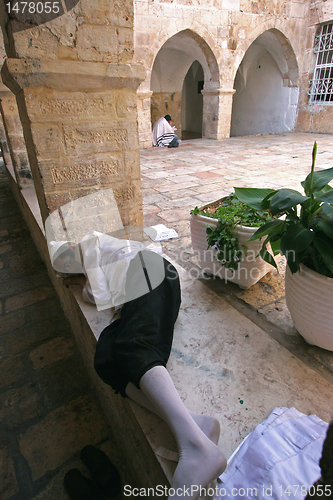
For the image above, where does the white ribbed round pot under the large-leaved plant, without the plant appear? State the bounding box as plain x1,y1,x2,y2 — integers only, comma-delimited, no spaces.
286,264,333,351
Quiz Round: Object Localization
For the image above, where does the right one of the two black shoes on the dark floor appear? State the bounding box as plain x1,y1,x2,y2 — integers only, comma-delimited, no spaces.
80,445,121,498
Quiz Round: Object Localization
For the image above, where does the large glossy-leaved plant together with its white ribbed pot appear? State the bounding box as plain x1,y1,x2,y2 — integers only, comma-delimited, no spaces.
235,142,333,351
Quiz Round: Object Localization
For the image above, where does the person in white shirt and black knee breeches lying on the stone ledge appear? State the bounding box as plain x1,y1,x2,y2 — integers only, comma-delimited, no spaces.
50,231,226,500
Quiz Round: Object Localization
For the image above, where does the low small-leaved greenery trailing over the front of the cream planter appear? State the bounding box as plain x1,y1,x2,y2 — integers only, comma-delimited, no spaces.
191,193,271,270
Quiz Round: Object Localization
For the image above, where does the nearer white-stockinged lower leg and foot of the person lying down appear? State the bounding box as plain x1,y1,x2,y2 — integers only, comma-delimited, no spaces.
140,366,226,500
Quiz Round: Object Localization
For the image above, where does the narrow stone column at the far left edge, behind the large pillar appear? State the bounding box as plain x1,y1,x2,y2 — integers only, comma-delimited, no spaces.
0,83,33,189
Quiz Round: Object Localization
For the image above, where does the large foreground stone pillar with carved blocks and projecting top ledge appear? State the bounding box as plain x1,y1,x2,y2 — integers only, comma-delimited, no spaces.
2,58,145,225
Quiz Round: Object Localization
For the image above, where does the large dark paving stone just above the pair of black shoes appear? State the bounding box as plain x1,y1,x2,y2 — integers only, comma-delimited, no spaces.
19,396,108,481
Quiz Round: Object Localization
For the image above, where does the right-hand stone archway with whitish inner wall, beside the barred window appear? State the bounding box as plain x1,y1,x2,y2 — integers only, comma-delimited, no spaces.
230,28,299,136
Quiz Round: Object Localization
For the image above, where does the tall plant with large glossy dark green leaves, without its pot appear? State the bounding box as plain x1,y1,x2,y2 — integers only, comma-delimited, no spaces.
235,142,333,277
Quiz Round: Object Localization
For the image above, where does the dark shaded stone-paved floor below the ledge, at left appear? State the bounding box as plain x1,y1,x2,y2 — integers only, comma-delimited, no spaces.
0,159,125,500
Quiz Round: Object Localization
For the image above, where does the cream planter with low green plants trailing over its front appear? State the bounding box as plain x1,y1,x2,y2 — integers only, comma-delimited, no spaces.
190,193,273,288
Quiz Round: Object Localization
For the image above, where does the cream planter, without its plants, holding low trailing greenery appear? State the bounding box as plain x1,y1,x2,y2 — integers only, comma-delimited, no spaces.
190,198,274,288
